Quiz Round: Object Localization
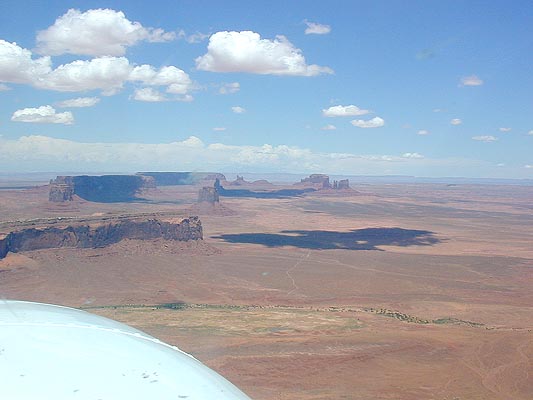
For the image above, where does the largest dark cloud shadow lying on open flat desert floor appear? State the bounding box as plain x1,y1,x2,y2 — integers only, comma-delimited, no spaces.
212,228,441,250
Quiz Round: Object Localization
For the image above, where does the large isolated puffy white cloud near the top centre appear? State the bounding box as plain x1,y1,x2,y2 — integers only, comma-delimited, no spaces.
195,31,333,76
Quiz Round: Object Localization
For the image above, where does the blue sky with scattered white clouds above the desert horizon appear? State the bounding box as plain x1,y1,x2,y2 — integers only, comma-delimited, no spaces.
0,0,533,178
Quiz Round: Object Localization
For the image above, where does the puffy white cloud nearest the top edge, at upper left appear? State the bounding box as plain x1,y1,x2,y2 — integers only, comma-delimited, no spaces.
37,9,176,56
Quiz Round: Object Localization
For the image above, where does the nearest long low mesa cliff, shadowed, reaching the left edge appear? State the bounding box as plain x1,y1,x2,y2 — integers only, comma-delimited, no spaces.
0,217,203,258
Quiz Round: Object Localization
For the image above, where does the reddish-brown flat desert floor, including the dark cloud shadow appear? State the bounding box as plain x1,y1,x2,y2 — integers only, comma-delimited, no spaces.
0,184,533,400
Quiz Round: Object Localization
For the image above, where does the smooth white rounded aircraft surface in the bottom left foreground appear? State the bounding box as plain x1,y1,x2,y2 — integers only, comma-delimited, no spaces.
0,301,250,400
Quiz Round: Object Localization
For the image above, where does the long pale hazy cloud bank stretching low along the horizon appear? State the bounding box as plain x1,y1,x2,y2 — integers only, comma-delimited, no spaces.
0,136,494,176
